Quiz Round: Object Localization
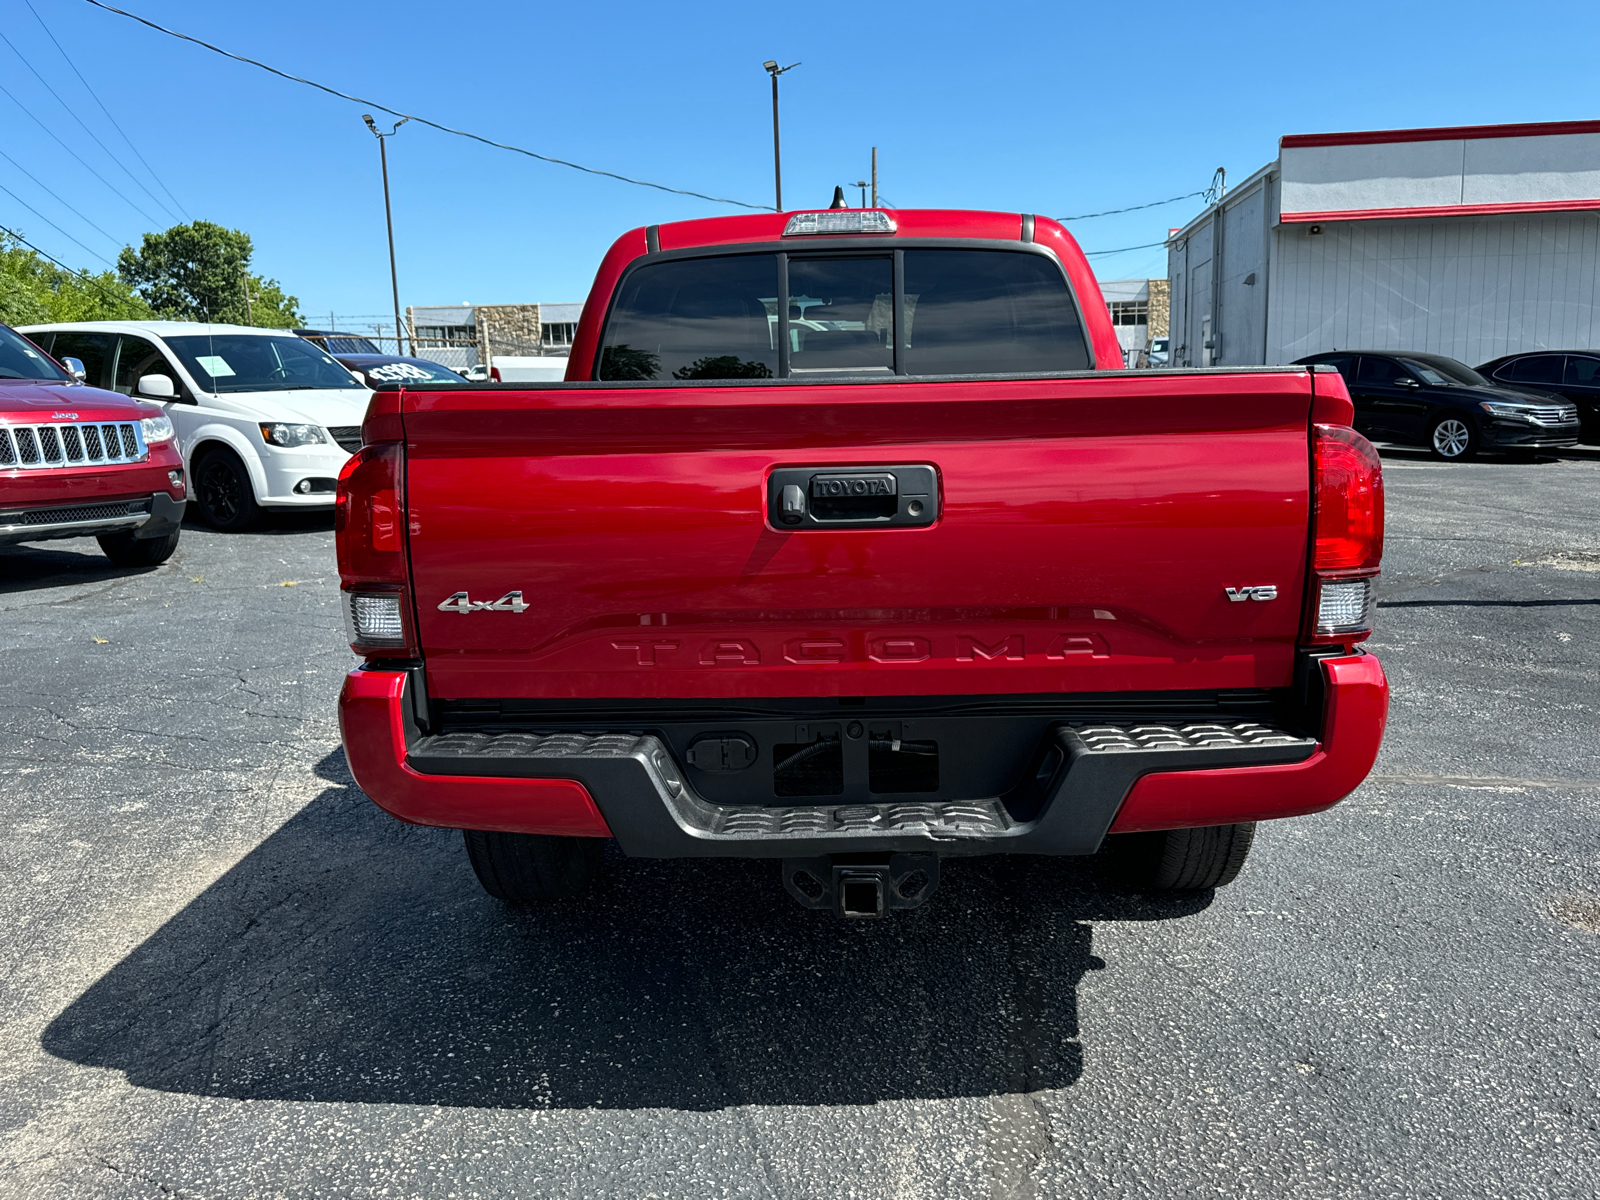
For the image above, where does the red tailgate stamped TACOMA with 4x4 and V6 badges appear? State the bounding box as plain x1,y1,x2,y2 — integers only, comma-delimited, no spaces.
402,370,1312,699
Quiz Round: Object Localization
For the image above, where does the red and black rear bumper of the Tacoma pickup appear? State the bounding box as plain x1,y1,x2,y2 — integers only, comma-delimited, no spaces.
339,654,1389,858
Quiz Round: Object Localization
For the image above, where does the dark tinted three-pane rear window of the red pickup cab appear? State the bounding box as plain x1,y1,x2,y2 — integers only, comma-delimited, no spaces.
595,248,1093,381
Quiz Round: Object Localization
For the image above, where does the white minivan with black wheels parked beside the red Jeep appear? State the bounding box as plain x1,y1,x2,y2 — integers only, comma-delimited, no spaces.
19,320,371,530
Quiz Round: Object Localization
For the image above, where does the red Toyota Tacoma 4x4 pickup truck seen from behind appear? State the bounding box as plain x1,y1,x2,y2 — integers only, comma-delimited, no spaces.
336,210,1387,917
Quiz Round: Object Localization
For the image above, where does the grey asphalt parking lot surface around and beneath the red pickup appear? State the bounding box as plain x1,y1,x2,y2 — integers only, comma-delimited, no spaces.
0,451,1600,1200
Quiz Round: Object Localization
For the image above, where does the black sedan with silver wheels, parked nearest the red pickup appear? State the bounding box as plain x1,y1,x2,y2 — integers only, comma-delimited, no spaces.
1298,350,1578,459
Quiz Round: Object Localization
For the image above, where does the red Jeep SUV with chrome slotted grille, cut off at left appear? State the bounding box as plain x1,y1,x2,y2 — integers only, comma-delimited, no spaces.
0,325,187,566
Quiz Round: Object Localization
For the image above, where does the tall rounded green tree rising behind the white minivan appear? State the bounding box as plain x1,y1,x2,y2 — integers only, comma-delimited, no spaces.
117,221,304,330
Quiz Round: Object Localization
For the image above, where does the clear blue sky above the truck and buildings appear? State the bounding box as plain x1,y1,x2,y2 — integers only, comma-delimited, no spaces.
0,0,1600,334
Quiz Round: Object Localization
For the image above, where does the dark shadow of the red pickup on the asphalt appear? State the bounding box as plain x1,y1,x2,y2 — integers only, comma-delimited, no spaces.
42,752,1210,1110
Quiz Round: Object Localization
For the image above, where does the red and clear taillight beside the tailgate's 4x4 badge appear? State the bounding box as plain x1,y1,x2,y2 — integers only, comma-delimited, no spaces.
333,442,418,658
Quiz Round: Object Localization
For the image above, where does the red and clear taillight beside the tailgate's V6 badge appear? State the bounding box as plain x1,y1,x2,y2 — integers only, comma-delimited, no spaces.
1304,426,1384,645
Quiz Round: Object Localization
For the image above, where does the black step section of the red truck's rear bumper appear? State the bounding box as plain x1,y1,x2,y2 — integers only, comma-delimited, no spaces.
408,720,1317,859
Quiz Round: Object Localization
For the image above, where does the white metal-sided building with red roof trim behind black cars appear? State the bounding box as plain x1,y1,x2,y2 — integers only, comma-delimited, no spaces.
1168,122,1600,366
